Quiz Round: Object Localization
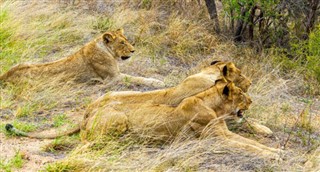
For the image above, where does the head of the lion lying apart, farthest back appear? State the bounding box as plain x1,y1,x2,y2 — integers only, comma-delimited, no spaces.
102,29,134,60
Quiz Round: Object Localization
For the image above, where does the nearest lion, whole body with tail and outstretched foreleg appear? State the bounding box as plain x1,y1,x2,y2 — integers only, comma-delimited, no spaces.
6,79,279,158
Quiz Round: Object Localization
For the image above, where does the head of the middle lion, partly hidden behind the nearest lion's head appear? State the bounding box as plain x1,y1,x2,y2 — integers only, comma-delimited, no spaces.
211,61,252,92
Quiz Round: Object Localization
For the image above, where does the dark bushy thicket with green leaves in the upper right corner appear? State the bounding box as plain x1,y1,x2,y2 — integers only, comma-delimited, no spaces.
222,0,320,94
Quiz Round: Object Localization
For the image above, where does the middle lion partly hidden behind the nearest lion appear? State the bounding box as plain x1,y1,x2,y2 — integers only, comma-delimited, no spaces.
89,61,252,106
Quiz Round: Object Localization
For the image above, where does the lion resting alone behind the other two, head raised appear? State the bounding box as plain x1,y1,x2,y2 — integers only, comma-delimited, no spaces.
0,29,165,87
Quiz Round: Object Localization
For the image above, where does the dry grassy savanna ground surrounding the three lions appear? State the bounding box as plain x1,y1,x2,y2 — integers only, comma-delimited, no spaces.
0,0,320,171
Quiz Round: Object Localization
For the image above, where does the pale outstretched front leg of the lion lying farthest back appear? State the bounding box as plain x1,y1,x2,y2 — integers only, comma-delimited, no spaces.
120,73,165,88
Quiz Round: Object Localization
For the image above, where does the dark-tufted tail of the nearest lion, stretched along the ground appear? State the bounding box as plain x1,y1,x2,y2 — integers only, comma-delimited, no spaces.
5,124,80,139
